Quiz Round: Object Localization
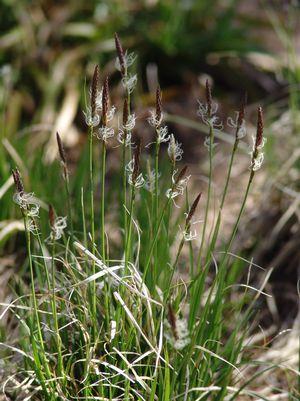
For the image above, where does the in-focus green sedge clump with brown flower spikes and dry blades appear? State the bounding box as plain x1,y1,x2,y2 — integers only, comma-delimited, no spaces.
1,35,297,401
